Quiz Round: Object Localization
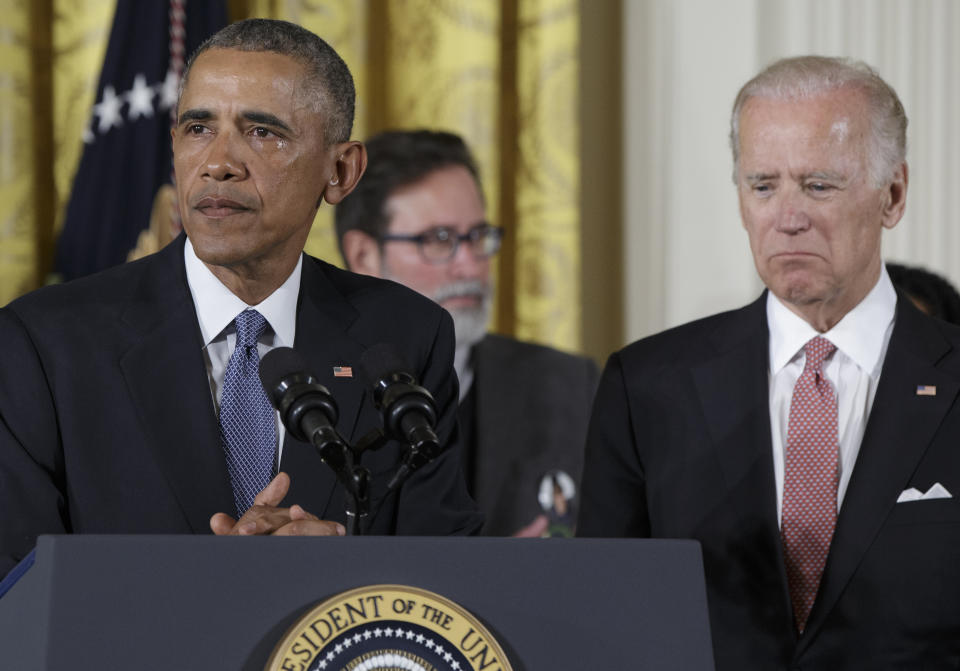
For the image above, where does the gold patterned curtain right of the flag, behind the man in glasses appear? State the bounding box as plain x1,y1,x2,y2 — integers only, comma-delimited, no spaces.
292,0,581,350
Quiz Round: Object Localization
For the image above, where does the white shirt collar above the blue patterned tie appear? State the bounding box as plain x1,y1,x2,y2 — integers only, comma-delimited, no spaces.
183,238,303,347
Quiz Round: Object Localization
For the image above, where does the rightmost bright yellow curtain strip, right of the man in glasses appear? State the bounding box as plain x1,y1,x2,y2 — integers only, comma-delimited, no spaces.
510,0,581,349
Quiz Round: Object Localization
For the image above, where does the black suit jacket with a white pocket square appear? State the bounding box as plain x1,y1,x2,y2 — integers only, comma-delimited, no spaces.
579,296,960,671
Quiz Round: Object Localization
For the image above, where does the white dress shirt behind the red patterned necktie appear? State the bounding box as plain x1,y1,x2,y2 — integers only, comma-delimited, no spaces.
767,267,897,520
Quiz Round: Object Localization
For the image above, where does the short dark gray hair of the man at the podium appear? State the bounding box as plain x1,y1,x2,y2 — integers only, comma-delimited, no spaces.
177,19,356,146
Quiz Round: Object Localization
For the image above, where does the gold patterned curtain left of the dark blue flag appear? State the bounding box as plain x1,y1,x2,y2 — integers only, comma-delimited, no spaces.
0,0,114,305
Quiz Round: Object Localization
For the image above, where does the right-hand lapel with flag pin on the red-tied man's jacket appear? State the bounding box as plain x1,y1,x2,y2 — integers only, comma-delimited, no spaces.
798,296,960,653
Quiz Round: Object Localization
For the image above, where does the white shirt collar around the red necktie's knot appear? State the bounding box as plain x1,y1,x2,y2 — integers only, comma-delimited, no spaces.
767,266,897,379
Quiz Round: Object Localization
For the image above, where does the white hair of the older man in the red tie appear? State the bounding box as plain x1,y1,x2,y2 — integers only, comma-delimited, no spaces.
730,56,907,188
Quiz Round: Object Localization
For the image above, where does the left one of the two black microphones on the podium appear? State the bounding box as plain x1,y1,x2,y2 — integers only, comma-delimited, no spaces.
260,347,351,477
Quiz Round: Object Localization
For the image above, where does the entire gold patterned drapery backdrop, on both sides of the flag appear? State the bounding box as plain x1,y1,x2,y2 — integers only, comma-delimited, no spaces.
0,0,581,350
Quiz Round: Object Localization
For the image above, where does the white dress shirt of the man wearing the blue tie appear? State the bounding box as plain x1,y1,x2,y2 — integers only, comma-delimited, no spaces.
183,238,303,470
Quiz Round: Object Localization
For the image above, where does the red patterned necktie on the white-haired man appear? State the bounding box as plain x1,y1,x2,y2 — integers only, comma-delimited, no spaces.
780,336,839,633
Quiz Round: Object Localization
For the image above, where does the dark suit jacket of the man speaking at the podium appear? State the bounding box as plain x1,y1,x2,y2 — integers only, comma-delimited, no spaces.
0,238,481,575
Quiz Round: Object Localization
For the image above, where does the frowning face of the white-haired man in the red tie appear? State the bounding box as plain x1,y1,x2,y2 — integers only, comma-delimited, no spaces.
737,90,906,330
